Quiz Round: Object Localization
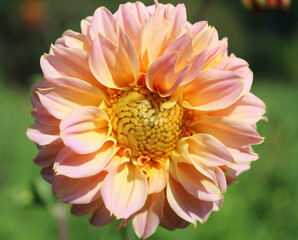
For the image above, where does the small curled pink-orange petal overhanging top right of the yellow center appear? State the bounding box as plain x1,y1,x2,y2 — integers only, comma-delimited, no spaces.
146,52,189,97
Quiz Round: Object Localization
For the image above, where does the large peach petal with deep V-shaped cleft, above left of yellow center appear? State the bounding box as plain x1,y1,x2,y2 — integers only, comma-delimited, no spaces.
89,29,139,89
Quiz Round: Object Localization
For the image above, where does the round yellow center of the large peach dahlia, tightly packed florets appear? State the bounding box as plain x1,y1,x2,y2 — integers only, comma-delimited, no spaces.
108,88,183,162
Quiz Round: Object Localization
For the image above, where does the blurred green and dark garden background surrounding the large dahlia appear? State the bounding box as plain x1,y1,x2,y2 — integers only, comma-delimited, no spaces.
0,0,298,240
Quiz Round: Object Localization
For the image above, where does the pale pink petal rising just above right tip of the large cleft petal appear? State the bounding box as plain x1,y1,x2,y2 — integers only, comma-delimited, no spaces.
116,5,142,55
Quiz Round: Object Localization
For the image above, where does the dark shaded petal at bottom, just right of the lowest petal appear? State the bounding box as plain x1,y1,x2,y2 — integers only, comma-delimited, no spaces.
160,197,189,231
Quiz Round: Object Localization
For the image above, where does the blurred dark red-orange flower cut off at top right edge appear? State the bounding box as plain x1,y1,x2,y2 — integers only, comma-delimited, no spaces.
242,0,291,10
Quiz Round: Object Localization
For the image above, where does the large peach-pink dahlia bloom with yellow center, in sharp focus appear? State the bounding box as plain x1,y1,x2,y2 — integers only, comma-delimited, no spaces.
27,1,265,238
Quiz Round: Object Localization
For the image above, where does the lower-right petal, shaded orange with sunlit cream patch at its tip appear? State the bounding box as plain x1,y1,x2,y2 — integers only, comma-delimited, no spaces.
176,163,223,201
